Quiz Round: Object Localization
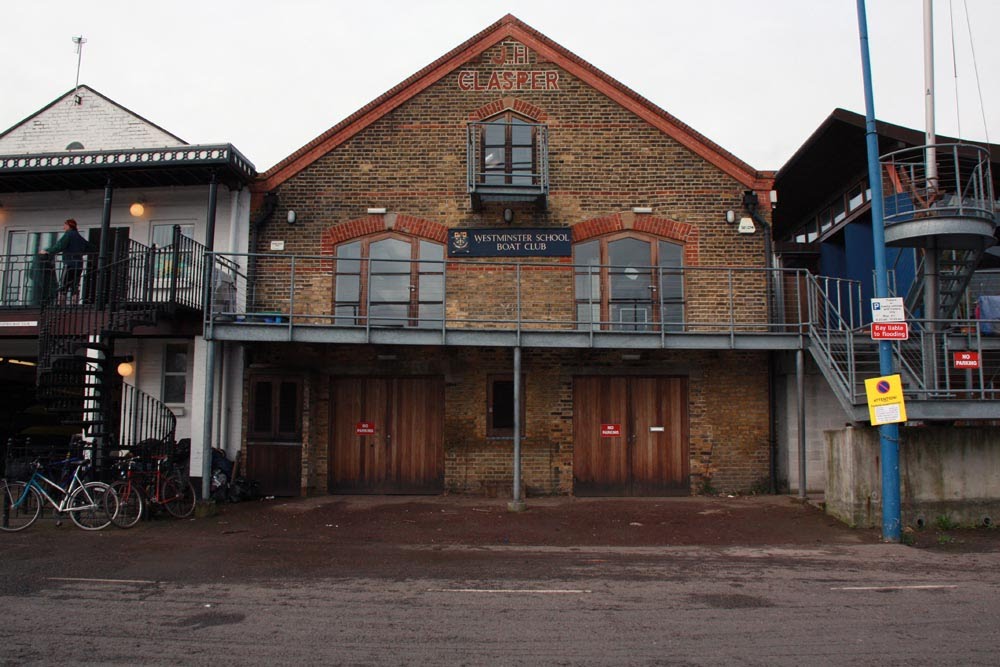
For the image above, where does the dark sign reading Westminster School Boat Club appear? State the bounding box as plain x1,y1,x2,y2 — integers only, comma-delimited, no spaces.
448,227,573,257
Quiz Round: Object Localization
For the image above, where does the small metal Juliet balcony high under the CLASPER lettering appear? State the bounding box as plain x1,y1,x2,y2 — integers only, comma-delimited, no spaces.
466,120,549,211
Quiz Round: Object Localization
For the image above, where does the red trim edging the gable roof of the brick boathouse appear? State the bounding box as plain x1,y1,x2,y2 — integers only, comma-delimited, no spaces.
254,14,774,192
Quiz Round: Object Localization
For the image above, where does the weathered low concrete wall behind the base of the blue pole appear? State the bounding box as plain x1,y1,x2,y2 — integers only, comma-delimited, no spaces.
824,427,1000,528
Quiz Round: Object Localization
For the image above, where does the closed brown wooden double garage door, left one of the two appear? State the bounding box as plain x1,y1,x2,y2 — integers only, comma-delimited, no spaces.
329,377,444,494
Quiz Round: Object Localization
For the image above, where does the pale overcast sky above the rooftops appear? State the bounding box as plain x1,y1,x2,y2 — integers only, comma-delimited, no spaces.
0,0,1000,172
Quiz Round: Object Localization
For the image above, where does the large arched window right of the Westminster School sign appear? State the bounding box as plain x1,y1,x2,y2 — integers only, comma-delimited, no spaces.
573,232,684,331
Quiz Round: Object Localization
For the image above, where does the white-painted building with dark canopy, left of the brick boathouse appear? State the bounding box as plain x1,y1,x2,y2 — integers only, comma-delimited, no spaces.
0,86,256,486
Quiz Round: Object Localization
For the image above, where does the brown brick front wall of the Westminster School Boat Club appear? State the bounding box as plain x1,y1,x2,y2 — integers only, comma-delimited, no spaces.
248,36,769,494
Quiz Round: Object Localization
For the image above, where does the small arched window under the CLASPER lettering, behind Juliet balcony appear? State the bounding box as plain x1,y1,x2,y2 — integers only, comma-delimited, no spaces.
479,111,538,185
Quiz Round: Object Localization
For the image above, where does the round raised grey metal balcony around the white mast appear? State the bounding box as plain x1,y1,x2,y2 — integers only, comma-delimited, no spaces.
880,144,996,250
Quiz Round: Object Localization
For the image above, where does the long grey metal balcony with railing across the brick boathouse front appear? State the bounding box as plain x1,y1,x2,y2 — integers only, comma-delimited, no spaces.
206,253,809,349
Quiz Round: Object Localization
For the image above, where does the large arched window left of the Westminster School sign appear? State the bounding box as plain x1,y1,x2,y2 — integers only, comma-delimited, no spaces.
333,234,444,327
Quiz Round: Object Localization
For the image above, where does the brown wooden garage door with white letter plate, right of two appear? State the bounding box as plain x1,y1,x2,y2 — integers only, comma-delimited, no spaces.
573,377,690,496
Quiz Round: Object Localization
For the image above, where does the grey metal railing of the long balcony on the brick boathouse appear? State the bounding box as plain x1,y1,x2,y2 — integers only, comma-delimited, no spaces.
206,253,808,335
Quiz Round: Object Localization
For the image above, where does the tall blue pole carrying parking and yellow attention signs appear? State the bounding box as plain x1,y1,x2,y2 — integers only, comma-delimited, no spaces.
858,0,901,542
